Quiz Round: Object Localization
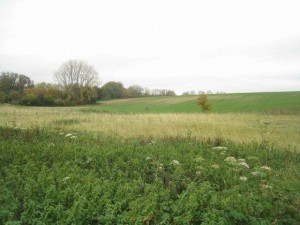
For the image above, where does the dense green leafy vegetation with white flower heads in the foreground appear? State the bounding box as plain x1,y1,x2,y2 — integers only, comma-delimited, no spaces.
0,127,300,224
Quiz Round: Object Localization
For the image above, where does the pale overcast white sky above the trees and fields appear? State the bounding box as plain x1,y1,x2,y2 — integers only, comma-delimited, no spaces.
0,0,300,94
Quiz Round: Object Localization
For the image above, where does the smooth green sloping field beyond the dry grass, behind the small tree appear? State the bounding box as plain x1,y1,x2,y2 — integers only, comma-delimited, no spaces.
84,92,300,113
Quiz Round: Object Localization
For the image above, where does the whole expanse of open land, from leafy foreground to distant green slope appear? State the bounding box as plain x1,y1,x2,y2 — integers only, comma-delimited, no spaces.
0,92,300,225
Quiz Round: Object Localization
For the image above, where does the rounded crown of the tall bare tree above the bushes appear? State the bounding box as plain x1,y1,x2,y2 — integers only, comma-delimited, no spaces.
54,60,99,88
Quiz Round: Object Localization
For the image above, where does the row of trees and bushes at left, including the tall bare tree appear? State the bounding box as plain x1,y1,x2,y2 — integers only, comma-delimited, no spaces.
0,60,176,106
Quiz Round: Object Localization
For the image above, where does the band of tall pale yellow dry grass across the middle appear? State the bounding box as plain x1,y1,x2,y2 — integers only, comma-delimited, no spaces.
0,105,300,151
